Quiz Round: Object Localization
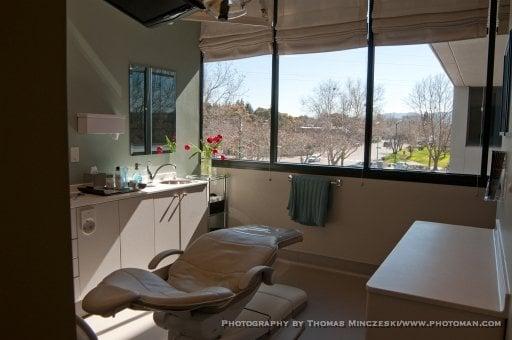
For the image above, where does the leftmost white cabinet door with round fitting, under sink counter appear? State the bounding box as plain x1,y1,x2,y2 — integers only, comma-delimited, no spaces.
77,202,121,300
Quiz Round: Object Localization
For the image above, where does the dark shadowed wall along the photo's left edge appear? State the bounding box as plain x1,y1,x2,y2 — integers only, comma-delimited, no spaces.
0,0,75,340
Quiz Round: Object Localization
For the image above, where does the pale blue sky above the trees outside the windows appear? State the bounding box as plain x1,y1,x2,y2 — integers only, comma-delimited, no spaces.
205,45,444,116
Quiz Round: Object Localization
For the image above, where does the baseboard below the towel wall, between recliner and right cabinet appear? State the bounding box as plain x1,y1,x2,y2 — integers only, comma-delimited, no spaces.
279,249,379,277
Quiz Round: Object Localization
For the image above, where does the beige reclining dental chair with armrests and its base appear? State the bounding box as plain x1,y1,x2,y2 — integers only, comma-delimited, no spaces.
82,226,307,339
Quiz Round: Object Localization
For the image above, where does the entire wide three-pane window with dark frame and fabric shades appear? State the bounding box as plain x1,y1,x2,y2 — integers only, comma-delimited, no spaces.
200,0,508,185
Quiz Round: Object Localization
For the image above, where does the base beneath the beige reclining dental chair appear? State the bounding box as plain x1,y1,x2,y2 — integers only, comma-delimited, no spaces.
158,284,307,340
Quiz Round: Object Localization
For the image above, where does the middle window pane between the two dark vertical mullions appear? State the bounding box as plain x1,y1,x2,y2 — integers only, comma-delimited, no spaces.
277,48,368,167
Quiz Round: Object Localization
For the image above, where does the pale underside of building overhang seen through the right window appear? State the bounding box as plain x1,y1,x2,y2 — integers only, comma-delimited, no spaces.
431,35,508,86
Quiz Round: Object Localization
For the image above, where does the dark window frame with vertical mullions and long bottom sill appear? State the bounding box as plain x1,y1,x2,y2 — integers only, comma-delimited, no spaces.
199,0,497,187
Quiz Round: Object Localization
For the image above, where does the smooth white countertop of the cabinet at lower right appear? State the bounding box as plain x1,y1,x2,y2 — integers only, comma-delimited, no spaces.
367,221,505,317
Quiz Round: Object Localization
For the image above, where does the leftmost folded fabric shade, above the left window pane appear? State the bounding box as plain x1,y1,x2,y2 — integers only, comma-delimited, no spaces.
199,22,272,61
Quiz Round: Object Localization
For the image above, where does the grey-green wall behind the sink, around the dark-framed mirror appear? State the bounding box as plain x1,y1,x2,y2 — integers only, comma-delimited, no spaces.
67,0,200,183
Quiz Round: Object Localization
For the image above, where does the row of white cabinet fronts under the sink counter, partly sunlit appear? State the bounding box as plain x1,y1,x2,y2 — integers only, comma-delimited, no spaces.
71,185,208,301
